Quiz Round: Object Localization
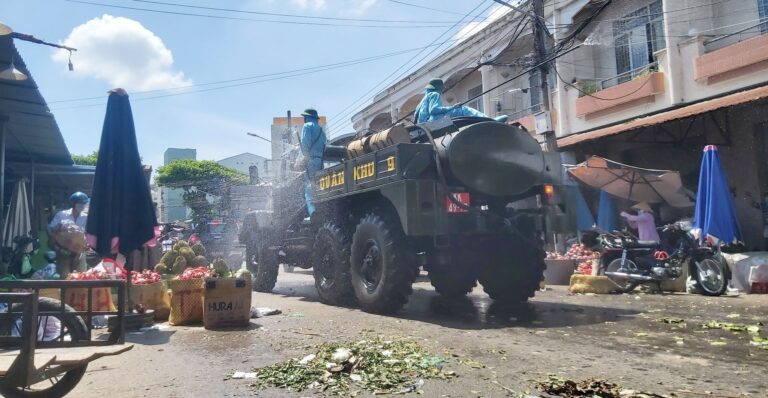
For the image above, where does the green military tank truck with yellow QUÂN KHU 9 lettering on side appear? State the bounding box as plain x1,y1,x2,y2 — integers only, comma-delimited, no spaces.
240,117,565,313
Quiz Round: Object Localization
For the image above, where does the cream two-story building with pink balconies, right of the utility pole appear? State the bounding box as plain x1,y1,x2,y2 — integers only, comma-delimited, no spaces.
552,0,768,248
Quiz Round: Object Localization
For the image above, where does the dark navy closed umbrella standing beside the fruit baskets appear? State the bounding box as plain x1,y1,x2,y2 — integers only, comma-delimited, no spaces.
86,89,157,257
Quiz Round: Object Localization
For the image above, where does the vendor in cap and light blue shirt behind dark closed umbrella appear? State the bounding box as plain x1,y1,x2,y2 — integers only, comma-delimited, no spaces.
48,192,90,278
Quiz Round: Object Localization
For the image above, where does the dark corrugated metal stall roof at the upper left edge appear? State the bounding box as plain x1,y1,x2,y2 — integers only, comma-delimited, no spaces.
0,35,72,165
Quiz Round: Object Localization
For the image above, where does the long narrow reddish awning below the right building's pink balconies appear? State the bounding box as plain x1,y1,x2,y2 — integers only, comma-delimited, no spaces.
557,86,768,148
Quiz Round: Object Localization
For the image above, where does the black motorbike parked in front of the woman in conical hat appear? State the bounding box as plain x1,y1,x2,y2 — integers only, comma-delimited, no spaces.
599,222,730,296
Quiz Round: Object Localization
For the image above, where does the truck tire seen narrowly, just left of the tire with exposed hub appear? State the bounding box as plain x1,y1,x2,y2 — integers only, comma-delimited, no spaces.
312,223,355,305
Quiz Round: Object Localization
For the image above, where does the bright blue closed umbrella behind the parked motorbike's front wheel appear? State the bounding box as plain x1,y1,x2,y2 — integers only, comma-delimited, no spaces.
694,145,743,243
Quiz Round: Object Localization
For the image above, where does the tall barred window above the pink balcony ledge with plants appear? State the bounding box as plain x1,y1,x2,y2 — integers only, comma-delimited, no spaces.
613,0,664,83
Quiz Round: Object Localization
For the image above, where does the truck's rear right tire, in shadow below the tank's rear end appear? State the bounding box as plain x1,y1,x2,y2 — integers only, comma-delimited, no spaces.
479,237,546,304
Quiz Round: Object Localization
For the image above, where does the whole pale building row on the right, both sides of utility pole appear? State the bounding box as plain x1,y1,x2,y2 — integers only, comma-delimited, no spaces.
352,0,768,249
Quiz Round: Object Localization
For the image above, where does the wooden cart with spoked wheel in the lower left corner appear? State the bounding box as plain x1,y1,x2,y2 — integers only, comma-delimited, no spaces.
0,280,133,398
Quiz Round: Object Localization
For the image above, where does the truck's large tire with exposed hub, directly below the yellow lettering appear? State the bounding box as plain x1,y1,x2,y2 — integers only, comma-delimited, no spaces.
350,212,418,314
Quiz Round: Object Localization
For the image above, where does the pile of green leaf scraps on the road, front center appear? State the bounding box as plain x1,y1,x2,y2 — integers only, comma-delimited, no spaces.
254,338,456,396
